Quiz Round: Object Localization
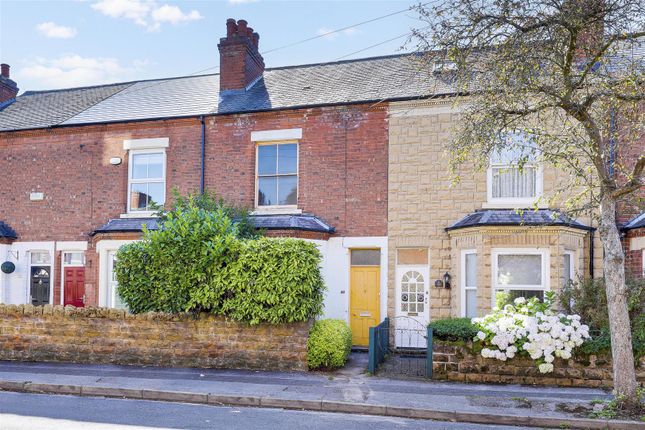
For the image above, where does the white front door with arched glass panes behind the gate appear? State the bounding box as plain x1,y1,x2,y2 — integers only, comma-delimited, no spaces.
395,266,430,348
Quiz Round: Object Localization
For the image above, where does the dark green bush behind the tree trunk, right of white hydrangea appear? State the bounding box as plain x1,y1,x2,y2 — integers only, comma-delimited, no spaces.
558,278,645,359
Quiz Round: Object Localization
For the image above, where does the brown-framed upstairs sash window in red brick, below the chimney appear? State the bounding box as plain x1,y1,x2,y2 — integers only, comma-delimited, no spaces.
257,142,298,207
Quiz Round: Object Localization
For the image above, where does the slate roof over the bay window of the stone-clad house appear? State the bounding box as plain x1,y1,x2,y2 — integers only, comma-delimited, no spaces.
446,209,595,231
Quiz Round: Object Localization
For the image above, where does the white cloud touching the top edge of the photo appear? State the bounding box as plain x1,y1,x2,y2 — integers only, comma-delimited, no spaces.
92,0,203,31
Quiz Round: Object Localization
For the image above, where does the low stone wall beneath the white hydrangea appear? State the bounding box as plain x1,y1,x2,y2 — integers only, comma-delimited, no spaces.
432,340,645,387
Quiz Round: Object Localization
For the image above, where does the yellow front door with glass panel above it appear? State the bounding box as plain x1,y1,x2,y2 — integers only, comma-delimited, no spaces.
349,249,381,346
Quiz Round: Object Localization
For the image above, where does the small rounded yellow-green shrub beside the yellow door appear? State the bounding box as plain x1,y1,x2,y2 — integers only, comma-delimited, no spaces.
307,319,352,369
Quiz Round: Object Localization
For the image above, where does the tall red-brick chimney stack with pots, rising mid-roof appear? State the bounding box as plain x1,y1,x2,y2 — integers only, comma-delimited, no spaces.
217,18,264,91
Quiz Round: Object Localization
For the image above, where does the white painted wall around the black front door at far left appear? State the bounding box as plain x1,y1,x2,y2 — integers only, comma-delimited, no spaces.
0,242,57,305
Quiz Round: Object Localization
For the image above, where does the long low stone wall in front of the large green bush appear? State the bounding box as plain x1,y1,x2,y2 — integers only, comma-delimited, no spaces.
0,305,311,370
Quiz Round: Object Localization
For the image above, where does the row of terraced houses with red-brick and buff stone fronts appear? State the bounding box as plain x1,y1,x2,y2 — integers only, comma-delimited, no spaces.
0,20,645,345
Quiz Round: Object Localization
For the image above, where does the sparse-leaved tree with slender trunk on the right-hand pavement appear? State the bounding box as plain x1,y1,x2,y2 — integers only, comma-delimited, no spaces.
411,0,645,406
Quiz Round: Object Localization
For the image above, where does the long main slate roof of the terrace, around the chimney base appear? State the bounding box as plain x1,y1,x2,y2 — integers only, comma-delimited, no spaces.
0,54,454,131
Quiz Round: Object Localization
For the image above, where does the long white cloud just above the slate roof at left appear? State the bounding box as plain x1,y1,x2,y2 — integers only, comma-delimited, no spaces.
17,54,146,89
